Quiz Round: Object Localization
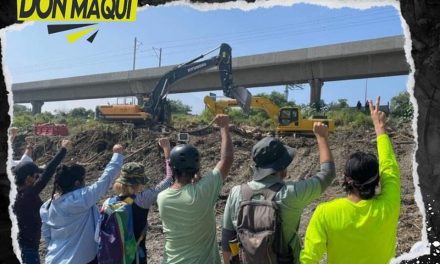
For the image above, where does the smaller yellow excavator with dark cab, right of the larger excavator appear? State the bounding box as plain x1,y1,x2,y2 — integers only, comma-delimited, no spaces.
204,96,335,134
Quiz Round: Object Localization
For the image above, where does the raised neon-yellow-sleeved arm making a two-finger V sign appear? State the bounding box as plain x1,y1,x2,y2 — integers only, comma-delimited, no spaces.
369,97,400,203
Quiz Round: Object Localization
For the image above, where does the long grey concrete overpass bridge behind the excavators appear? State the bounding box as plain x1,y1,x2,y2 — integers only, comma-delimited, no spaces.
12,36,409,113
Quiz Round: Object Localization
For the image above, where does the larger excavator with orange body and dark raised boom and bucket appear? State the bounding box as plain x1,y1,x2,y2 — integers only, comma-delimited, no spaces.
96,43,252,126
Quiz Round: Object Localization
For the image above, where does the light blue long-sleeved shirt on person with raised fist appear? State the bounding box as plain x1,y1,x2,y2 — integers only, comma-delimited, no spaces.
40,153,124,264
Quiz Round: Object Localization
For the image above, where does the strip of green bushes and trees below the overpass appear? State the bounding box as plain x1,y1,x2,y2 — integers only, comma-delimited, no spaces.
12,92,414,132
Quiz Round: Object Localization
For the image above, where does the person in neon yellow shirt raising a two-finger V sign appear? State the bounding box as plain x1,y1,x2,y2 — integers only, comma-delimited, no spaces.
301,97,400,264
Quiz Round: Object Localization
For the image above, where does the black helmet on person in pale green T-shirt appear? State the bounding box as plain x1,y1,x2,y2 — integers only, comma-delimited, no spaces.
170,144,200,173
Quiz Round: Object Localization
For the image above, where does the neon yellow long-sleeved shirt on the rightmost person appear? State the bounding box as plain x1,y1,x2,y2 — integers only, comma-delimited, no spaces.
301,135,400,264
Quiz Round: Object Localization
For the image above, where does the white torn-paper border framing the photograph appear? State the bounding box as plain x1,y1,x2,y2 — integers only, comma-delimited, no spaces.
0,0,428,263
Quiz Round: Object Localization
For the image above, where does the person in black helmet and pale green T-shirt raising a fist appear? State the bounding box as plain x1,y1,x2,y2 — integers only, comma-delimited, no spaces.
157,115,234,264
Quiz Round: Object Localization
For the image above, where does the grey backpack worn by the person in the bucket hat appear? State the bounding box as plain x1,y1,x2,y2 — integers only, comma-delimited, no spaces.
237,183,293,264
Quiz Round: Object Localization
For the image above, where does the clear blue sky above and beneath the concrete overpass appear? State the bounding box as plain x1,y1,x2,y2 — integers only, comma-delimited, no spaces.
3,4,407,114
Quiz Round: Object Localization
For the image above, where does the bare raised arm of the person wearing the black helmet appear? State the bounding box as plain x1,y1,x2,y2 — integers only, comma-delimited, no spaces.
215,114,234,180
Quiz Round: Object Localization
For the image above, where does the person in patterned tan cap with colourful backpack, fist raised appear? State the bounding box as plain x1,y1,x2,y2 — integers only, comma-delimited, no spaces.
95,138,173,264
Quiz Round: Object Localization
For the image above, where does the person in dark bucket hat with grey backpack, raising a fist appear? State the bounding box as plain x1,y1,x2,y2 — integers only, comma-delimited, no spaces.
221,122,335,264
